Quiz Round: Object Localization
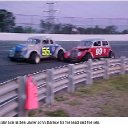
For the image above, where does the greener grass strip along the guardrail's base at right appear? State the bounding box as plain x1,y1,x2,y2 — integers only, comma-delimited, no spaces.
73,75,128,97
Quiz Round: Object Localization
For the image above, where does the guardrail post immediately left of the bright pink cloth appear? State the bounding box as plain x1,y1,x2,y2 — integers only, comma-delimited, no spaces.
17,76,28,117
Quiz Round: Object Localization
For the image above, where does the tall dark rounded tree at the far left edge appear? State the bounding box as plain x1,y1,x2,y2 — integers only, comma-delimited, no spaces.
0,9,15,32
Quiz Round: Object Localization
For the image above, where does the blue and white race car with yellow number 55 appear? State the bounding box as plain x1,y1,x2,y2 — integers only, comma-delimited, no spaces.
8,36,65,64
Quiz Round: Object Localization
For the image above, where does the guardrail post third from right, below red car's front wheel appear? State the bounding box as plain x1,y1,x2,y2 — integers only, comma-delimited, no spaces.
86,59,93,85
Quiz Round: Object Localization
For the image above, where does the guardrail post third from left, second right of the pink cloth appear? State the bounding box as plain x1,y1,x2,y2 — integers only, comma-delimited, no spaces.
68,64,75,93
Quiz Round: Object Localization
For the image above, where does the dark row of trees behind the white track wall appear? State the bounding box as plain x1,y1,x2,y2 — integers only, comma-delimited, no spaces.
0,9,128,34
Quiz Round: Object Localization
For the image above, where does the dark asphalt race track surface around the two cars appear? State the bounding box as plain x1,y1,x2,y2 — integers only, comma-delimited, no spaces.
0,41,128,83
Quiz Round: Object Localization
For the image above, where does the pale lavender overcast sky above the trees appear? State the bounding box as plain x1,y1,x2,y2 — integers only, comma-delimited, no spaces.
0,1,128,28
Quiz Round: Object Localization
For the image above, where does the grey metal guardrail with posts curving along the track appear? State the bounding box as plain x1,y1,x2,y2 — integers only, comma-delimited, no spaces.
0,57,128,116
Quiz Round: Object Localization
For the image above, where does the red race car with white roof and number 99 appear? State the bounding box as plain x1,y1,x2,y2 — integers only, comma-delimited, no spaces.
64,39,115,62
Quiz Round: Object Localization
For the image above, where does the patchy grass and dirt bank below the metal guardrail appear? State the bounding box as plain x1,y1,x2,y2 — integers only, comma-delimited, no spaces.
29,75,128,117
